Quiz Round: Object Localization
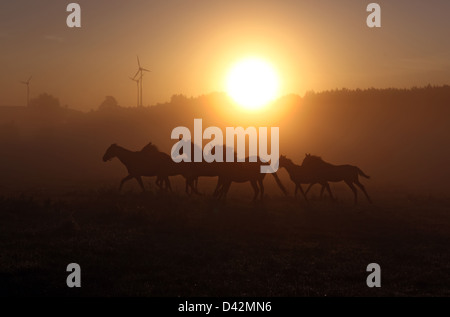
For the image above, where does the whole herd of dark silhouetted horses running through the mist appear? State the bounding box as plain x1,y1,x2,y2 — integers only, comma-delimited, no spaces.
103,143,372,204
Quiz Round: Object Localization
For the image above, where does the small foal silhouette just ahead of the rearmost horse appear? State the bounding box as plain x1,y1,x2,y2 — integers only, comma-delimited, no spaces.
279,155,333,201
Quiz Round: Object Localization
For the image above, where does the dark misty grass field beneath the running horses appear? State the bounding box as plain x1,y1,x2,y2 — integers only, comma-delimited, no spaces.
0,185,450,296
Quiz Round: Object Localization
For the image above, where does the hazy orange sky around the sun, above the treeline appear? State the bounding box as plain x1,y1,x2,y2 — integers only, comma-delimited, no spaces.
0,0,450,110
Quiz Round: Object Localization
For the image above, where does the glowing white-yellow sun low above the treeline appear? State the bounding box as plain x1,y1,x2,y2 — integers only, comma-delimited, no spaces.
226,57,279,110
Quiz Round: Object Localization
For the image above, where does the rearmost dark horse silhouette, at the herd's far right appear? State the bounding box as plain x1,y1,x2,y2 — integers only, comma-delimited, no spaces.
302,154,372,204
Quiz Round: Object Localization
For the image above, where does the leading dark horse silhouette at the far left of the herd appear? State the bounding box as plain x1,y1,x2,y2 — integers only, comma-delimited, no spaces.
103,144,172,192
